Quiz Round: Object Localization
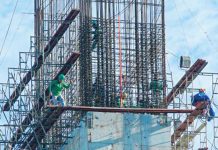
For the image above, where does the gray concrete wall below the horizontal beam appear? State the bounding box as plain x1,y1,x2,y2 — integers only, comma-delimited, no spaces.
62,113,171,150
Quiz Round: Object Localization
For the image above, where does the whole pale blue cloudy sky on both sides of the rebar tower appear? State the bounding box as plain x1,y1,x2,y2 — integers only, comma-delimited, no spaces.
0,0,218,149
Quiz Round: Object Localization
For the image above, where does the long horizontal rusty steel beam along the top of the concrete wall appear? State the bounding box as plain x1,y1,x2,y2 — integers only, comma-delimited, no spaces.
47,106,193,114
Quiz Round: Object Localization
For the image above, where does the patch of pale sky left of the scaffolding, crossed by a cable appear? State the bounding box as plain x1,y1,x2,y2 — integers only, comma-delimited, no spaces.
0,0,34,83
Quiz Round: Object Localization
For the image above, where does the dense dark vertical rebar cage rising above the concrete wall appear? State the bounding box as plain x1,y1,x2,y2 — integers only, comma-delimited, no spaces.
79,0,166,107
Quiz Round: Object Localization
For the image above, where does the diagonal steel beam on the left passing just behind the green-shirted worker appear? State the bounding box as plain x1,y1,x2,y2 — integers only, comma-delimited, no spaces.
10,52,80,147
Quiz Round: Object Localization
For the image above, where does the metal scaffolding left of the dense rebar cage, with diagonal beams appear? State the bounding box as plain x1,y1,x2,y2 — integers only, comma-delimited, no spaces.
0,1,82,149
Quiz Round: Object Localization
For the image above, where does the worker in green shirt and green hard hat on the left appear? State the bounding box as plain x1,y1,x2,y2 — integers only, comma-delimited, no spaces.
49,74,70,106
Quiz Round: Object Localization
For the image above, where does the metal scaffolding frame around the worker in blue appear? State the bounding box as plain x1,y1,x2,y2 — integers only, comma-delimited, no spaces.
169,72,218,149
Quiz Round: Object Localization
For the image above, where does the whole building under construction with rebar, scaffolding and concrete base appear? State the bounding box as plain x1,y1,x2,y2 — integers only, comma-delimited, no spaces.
0,0,218,150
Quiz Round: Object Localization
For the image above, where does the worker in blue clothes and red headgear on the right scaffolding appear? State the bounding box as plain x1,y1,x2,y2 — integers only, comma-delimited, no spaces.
192,88,215,121
